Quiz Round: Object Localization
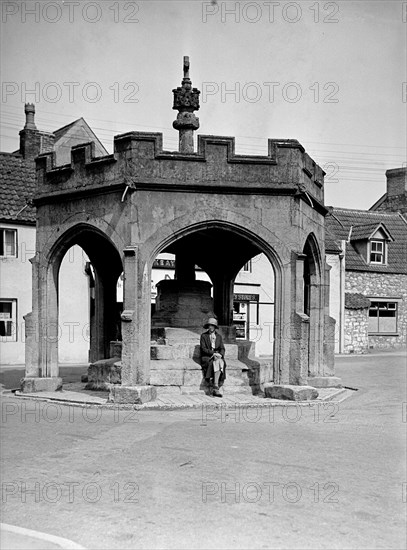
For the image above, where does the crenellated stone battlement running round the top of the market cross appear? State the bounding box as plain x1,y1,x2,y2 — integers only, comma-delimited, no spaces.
36,132,325,204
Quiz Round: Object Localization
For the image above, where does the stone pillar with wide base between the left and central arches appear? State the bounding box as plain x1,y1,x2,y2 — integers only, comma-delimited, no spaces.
109,246,157,403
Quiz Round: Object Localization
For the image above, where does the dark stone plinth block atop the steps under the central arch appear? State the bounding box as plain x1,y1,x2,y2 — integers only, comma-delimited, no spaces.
152,279,213,330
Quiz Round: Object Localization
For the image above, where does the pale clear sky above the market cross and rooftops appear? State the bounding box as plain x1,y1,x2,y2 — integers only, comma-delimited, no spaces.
0,0,407,209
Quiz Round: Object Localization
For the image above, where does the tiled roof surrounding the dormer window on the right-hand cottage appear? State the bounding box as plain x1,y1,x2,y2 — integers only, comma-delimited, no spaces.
325,207,407,274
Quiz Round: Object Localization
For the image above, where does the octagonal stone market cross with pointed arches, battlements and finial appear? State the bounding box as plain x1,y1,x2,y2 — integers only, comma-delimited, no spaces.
22,58,338,403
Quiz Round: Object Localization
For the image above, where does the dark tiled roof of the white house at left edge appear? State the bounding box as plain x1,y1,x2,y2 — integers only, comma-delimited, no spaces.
0,153,35,223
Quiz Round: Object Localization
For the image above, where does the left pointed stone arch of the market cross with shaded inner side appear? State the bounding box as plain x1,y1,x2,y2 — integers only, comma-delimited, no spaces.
37,223,123,376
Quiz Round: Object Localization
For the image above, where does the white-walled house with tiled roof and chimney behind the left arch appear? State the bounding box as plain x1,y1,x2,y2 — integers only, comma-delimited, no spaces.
0,104,107,364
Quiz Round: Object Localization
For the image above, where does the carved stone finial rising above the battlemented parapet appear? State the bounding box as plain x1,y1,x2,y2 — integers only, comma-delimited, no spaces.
172,55,201,153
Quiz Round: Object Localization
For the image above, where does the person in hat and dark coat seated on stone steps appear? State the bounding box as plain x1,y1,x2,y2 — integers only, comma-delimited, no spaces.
201,317,226,397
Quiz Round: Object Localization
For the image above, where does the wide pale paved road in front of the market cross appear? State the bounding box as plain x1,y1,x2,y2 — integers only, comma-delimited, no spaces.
1,353,407,549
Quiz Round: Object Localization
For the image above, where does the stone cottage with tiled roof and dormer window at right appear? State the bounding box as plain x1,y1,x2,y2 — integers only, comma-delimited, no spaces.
326,168,407,353
